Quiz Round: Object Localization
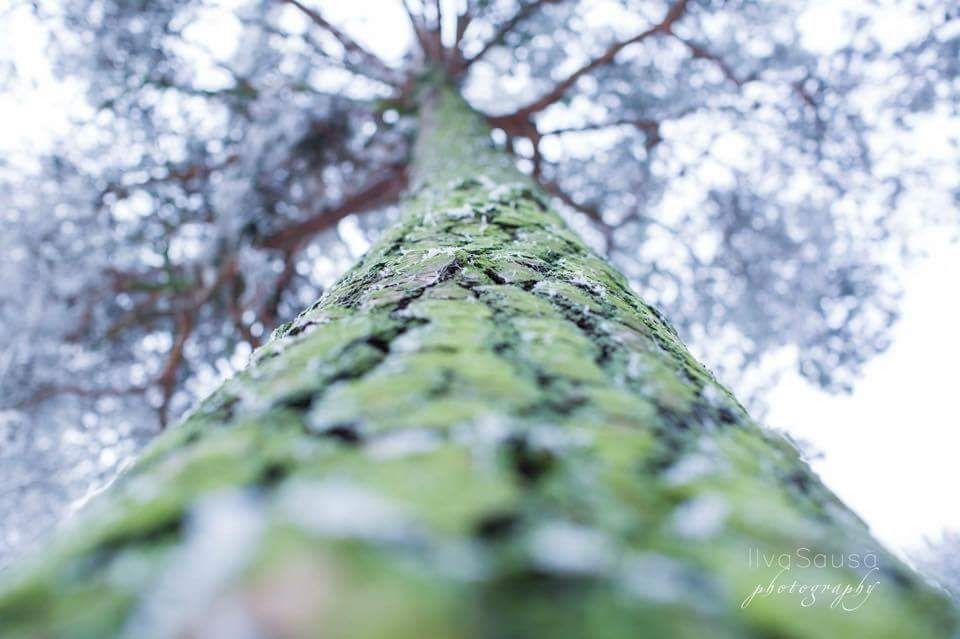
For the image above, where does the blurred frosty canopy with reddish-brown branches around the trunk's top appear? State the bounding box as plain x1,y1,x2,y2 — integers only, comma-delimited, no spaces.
0,0,960,563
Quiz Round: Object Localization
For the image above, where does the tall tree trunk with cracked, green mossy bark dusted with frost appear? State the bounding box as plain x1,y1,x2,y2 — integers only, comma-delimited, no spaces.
0,88,957,639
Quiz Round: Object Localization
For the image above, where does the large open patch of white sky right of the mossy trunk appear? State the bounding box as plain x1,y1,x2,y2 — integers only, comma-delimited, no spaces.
767,238,960,551
